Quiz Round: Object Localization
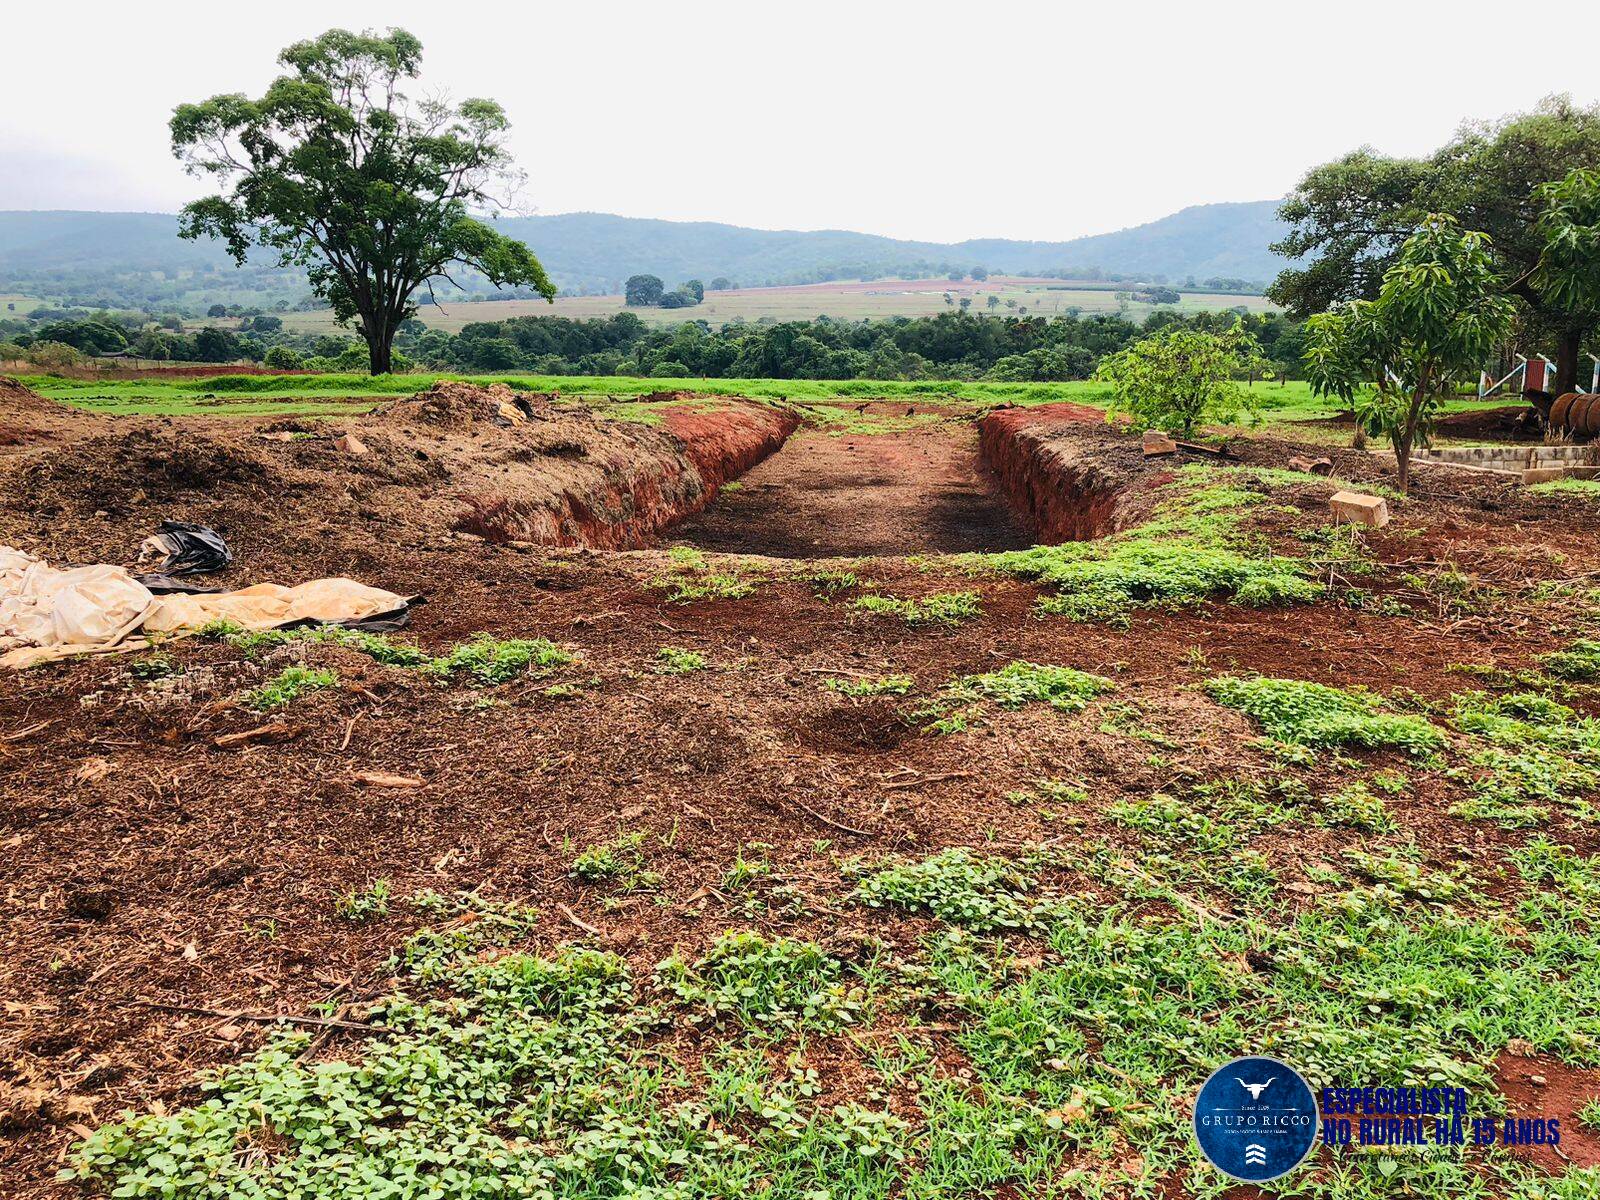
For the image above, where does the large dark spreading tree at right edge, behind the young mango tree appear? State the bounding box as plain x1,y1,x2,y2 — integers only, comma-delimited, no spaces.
1267,96,1600,392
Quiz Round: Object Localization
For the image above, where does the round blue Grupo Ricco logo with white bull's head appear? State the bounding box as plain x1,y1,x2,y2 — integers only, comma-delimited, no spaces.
1195,1056,1318,1184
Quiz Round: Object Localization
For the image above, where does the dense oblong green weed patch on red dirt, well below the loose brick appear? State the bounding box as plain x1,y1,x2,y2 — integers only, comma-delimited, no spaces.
1205,675,1445,755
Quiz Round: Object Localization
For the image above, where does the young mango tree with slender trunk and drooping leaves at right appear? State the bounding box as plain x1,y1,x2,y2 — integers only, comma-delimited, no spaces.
1306,213,1515,491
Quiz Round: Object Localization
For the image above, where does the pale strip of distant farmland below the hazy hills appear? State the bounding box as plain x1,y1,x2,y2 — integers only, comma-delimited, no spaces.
275,275,1272,333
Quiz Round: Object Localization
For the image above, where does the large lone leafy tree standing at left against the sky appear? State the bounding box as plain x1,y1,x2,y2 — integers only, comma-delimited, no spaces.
171,29,555,374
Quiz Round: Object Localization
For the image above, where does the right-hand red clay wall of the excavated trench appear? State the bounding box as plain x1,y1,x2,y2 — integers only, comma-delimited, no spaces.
978,403,1142,542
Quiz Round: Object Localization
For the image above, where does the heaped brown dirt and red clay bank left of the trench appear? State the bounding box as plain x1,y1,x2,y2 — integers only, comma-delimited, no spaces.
0,384,795,560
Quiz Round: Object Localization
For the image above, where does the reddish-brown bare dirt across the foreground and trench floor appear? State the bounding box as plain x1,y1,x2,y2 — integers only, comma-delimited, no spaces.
0,380,1600,1197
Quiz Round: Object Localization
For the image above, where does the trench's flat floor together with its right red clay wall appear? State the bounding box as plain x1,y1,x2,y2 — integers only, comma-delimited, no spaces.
662,405,1136,558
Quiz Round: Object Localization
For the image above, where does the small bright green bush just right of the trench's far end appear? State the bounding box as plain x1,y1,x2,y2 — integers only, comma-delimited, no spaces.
1094,322,1269,437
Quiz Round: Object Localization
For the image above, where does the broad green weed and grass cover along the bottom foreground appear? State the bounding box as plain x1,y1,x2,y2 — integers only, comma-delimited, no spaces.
62,832,1600,1200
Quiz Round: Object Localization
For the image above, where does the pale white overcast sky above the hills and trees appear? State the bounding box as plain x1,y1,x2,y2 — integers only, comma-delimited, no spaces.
0,0,1600,242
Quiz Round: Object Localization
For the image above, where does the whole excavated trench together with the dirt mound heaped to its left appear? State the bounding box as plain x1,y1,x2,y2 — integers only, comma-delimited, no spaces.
0,382,1144,565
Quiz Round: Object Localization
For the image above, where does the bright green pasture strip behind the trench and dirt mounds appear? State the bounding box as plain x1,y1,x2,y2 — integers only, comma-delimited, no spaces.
9,373,1506,442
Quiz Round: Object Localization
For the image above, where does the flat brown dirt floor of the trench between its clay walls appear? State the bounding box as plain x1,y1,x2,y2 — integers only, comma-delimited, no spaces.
666,422,1037,558
